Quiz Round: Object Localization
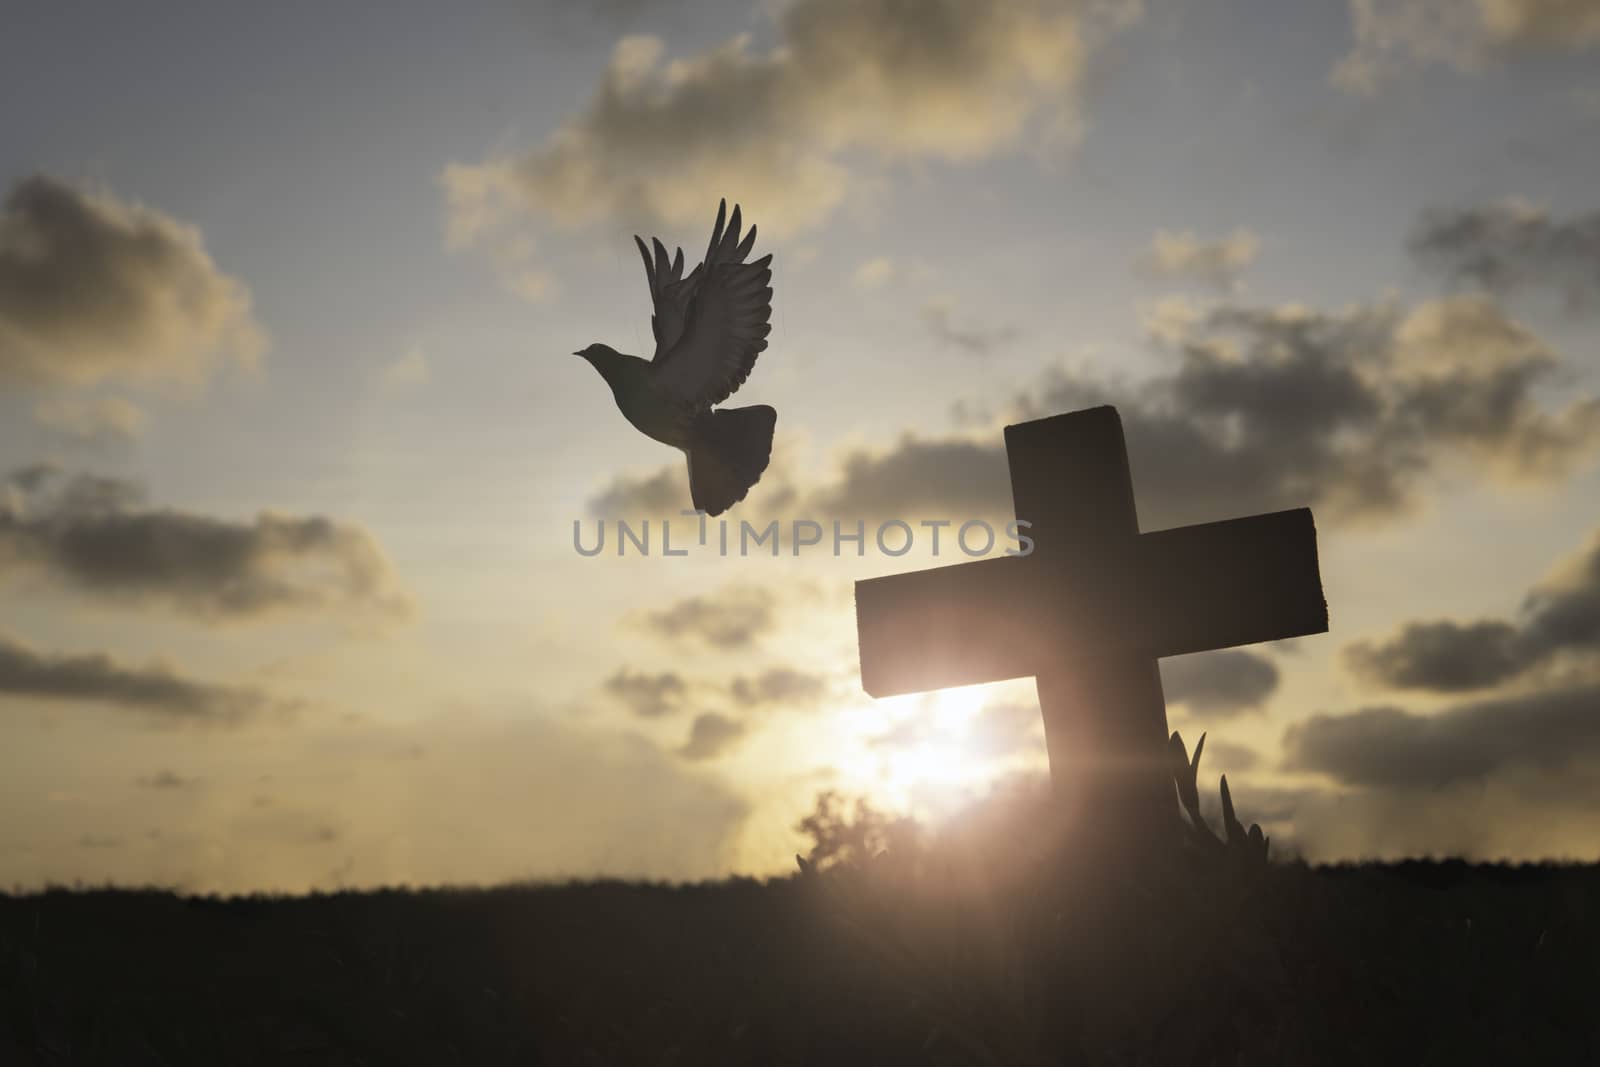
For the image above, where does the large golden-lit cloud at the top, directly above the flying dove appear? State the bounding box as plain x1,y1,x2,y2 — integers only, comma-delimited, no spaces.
442,0,1139,287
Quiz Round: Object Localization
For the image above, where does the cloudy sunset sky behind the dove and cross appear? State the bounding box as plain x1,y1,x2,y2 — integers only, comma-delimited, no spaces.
0,0,1600,893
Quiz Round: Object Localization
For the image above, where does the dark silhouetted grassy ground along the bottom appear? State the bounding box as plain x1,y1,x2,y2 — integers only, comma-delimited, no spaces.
0,856,1600,1067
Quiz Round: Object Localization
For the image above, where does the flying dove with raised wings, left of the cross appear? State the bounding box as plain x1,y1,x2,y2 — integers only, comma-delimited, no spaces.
573,200,778,515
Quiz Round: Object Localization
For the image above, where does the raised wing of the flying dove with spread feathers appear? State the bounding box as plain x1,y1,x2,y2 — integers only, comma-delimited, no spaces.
635,200,773,408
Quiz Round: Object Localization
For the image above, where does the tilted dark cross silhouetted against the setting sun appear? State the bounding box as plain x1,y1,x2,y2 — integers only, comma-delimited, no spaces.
856,406,1328,863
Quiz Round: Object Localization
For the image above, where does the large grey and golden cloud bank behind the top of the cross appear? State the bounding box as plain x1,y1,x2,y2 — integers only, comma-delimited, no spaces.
795,296,1600,530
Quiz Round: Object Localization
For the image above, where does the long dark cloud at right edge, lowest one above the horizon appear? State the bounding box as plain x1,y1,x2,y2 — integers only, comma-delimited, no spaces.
1283,685,1600,787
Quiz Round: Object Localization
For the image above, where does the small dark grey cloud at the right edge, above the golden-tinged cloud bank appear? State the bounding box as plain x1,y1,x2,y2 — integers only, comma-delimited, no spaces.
1410,202,1600,312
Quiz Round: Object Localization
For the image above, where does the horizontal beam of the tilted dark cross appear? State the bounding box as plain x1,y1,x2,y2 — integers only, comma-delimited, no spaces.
856,507,1328,697
